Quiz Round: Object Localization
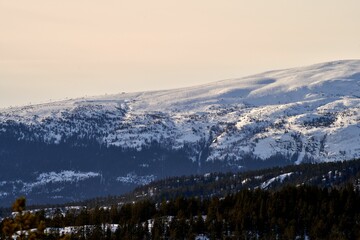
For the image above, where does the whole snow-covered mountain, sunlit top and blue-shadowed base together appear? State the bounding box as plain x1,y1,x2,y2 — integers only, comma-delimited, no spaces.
0,60,360,204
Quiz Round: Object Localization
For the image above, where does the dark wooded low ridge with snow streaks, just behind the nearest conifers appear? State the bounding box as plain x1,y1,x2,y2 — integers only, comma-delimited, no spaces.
83,160,360,206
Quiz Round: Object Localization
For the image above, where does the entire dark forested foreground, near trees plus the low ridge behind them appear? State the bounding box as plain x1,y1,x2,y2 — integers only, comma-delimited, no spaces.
0,160,360,239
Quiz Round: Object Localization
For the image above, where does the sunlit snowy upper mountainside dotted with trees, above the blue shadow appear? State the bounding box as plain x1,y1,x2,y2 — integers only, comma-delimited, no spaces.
0,60,360,163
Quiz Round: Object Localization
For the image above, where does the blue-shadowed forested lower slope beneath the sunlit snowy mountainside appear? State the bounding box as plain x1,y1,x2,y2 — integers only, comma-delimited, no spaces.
0,123,292,207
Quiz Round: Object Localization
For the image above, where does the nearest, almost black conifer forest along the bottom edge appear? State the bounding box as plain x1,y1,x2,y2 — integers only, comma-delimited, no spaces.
1,184,360,239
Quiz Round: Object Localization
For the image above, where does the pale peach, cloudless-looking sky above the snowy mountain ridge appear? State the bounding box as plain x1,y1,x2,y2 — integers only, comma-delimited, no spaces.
0,0,360,107
